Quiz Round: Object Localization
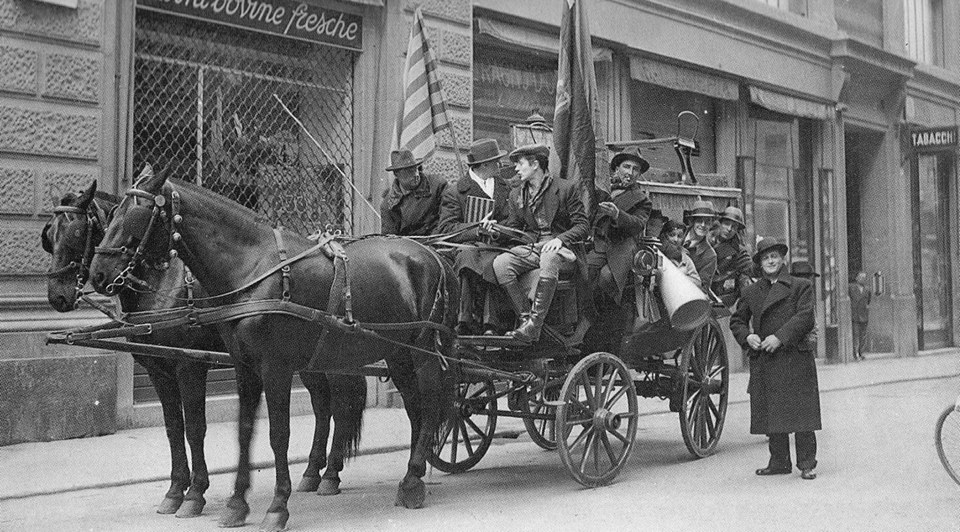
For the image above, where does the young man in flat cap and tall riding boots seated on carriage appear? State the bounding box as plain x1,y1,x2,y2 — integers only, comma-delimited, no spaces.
485,144,590,342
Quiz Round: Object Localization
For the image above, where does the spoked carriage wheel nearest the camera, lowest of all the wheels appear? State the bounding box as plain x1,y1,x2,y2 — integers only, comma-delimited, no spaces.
556,353,637,488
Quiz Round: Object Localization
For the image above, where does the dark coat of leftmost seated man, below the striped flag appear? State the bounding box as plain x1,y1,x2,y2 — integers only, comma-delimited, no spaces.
380,175,447,236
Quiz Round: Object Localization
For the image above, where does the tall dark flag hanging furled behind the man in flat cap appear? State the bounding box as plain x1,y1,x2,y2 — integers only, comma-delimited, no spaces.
553,0,610,218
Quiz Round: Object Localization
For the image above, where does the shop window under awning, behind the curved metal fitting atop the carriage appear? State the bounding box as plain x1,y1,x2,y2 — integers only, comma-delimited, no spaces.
630,80,719,179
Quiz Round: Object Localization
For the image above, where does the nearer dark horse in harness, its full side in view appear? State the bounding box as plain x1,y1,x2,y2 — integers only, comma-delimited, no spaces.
91,170,459,531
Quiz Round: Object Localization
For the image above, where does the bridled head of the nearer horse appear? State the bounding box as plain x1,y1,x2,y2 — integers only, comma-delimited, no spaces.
90,165,179,296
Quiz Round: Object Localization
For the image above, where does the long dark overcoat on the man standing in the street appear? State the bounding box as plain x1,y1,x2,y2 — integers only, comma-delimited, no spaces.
730,273,821,434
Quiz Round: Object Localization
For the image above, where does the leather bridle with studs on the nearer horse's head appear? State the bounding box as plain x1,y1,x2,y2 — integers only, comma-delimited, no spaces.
94,184,183,293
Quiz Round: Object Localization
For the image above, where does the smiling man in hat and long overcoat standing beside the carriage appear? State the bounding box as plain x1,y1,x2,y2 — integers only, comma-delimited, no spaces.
730,238,821,480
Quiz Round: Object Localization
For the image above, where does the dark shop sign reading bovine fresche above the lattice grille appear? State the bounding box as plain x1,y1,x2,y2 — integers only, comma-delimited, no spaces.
137,0,363,50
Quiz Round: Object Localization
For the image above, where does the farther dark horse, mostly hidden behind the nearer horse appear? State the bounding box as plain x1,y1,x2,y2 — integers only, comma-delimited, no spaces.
41,182,366,517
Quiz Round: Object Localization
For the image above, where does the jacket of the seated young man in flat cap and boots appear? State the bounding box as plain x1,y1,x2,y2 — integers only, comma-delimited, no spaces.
504,177,590,248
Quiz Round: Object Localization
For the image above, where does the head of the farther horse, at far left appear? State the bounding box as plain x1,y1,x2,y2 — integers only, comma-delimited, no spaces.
40,181,106,312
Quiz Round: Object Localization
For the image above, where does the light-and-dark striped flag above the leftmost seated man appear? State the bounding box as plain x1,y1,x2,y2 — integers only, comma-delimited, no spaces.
392,7,456,159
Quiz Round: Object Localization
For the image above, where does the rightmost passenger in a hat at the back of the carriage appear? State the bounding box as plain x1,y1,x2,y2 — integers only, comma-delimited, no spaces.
710,205,753,308
